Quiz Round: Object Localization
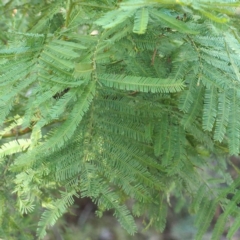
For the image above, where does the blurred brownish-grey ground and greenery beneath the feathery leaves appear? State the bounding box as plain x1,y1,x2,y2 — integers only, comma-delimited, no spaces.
41,188,240,240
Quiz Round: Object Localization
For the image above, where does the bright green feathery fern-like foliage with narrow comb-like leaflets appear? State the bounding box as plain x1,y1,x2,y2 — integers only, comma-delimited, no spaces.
0,0,240,240
